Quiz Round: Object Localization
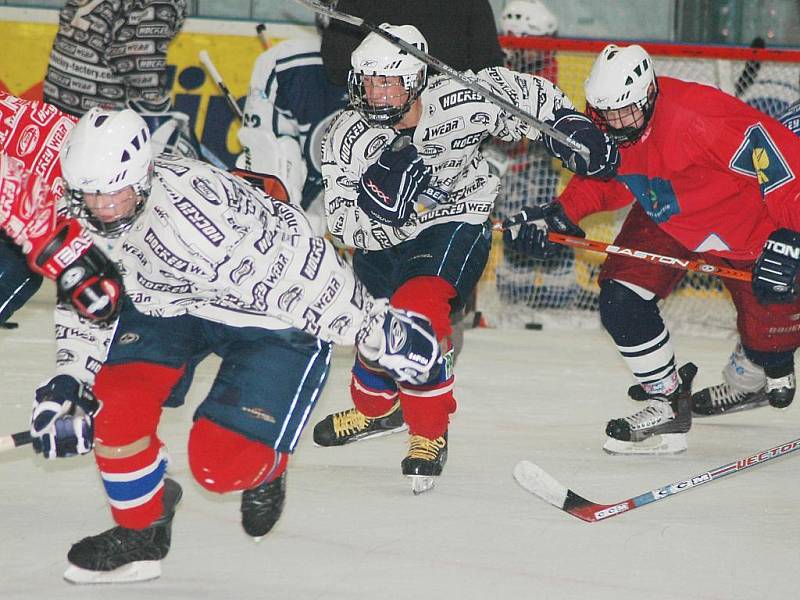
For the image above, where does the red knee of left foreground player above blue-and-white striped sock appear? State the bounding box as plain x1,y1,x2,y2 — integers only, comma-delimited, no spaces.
93,362,183,447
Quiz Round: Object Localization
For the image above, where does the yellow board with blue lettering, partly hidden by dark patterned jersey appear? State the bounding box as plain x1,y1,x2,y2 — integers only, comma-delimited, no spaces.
0,21,262,165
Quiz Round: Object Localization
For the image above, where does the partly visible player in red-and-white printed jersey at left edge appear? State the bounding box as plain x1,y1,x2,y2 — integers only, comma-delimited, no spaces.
0,91,121,323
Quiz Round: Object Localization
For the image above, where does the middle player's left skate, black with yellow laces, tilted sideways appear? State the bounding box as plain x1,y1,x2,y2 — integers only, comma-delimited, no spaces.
314,402,406,446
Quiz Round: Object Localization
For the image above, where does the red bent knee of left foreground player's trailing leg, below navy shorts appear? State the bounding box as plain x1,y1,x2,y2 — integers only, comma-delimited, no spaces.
189,417,288,494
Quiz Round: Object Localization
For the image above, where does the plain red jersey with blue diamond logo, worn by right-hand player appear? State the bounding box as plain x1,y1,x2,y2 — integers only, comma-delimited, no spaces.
559,77,800,260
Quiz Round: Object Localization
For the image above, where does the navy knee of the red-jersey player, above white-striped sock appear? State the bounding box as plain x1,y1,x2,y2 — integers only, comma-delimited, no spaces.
599,279,663,340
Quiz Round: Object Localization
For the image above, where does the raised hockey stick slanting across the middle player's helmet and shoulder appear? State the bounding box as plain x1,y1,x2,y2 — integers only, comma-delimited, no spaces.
288,0,589,164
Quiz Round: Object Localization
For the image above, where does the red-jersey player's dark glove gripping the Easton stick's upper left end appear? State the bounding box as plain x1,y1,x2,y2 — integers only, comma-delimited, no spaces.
503,202,586,260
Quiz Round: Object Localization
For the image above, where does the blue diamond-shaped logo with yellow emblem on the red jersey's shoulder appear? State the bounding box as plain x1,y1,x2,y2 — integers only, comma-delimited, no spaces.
730,123,794,196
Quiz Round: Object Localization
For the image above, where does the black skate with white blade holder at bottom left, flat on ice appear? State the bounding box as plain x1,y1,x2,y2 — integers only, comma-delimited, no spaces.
64,479,183,583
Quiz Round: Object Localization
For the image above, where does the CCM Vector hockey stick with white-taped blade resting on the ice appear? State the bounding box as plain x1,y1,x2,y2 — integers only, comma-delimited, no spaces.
514,439,800,523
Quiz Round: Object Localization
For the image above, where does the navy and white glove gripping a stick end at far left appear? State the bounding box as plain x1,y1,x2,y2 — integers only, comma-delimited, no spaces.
31,375,101,458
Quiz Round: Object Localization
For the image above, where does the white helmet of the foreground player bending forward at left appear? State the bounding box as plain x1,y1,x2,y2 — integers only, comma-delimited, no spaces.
60,108,154,237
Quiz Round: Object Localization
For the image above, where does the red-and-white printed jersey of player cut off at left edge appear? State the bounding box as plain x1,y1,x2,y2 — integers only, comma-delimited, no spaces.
0,91,77,254
